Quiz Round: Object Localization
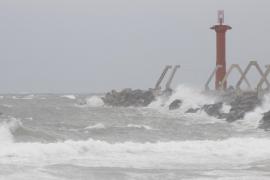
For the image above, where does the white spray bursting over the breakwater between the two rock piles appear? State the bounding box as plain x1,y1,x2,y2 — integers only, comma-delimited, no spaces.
148,84,216,111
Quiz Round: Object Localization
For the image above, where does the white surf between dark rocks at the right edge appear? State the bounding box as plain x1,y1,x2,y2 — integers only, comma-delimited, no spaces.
234,94,270,130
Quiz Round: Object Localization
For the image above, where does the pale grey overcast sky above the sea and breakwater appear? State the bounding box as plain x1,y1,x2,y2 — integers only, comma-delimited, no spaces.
0,0,270,93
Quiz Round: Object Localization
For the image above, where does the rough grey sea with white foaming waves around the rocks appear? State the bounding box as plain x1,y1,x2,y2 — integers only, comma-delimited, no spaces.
0,86,270,180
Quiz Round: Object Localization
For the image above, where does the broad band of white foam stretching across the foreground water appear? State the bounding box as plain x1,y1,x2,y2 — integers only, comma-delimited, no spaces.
0,138,270,169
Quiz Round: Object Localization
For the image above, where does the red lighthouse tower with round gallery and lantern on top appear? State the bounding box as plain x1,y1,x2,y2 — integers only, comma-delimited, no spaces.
211,10,232,90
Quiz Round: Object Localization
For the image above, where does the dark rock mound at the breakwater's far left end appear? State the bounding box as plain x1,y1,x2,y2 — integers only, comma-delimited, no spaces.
102,88,155,107
